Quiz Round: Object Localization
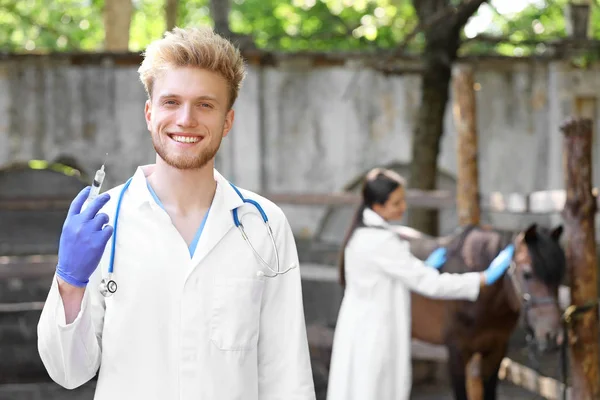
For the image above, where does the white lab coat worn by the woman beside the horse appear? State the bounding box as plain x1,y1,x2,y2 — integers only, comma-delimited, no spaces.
327,209,480,400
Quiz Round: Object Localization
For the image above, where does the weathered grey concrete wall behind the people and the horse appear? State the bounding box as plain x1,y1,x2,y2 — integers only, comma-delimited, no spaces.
0,55,600,236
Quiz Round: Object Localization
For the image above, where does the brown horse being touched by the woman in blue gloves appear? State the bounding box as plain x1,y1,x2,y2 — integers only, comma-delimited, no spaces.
398,224,566,400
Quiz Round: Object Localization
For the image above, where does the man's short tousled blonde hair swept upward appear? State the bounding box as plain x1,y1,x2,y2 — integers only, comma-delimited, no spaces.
138,27,246,108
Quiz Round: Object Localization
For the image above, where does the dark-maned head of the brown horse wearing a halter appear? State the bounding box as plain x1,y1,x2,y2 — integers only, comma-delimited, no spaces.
506,224,566,352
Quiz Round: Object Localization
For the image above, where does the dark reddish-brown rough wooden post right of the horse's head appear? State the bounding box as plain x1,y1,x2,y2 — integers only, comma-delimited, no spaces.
561,118,600,400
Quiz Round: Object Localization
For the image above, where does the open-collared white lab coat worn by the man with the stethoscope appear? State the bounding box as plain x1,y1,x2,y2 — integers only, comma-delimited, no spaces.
38,166,315,400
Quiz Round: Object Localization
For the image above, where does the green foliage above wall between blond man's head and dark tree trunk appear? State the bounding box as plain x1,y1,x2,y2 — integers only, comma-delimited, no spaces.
225,0,417,51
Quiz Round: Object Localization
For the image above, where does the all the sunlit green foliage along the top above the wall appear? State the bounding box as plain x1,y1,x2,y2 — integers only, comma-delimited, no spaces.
0,0,600,56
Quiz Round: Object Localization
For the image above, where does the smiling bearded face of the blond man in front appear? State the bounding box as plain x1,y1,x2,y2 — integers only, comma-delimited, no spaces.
145,67,234,169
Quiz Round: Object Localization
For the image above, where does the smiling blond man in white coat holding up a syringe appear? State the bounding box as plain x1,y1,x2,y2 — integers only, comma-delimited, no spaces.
38,28,315,400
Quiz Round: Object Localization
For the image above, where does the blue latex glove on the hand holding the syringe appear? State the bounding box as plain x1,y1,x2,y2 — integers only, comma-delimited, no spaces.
56,186,113,287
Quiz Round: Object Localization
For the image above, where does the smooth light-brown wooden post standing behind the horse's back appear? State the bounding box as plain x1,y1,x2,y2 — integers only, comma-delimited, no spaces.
452,65,480,226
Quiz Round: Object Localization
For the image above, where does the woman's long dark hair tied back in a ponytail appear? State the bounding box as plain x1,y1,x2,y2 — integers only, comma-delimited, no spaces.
338,168,405,288
